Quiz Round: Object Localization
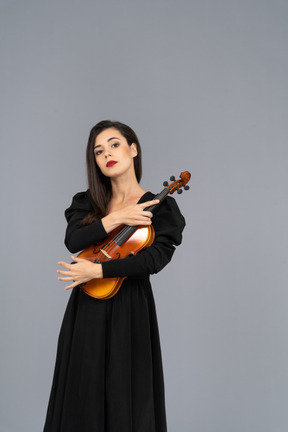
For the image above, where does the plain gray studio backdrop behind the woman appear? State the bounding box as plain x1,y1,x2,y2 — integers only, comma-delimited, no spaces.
0,0,288,432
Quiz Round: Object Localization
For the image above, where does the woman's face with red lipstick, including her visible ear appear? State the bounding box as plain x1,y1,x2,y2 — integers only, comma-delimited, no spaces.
94,128,137,178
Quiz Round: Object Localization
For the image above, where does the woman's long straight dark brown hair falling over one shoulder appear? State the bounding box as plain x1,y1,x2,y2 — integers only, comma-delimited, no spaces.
82,120,142,225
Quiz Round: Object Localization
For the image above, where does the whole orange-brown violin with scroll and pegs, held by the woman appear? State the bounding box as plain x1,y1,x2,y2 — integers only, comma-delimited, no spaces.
78,171,191,300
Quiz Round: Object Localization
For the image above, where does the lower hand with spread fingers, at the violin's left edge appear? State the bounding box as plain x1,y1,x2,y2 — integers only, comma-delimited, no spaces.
57,256,103,290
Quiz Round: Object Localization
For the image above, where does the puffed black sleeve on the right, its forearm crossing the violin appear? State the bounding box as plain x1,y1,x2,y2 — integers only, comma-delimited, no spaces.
102,194,185,278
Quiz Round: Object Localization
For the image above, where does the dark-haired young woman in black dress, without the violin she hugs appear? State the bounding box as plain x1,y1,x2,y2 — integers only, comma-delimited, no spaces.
44,120,185,432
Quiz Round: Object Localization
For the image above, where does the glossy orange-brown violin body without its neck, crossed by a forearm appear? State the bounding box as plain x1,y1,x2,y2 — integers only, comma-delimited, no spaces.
78,225,155,300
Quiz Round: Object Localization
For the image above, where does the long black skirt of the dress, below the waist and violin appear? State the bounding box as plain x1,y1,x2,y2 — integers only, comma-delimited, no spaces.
44,276,167,432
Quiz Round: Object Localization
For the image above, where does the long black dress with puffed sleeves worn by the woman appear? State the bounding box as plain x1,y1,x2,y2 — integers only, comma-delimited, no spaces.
44,192,185,432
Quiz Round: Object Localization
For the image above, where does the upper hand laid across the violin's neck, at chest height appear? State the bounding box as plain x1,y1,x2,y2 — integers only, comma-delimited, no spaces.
102,200,159,233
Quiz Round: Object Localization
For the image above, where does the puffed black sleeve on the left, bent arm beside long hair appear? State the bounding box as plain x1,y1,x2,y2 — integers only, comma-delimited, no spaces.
64,191,108,253
